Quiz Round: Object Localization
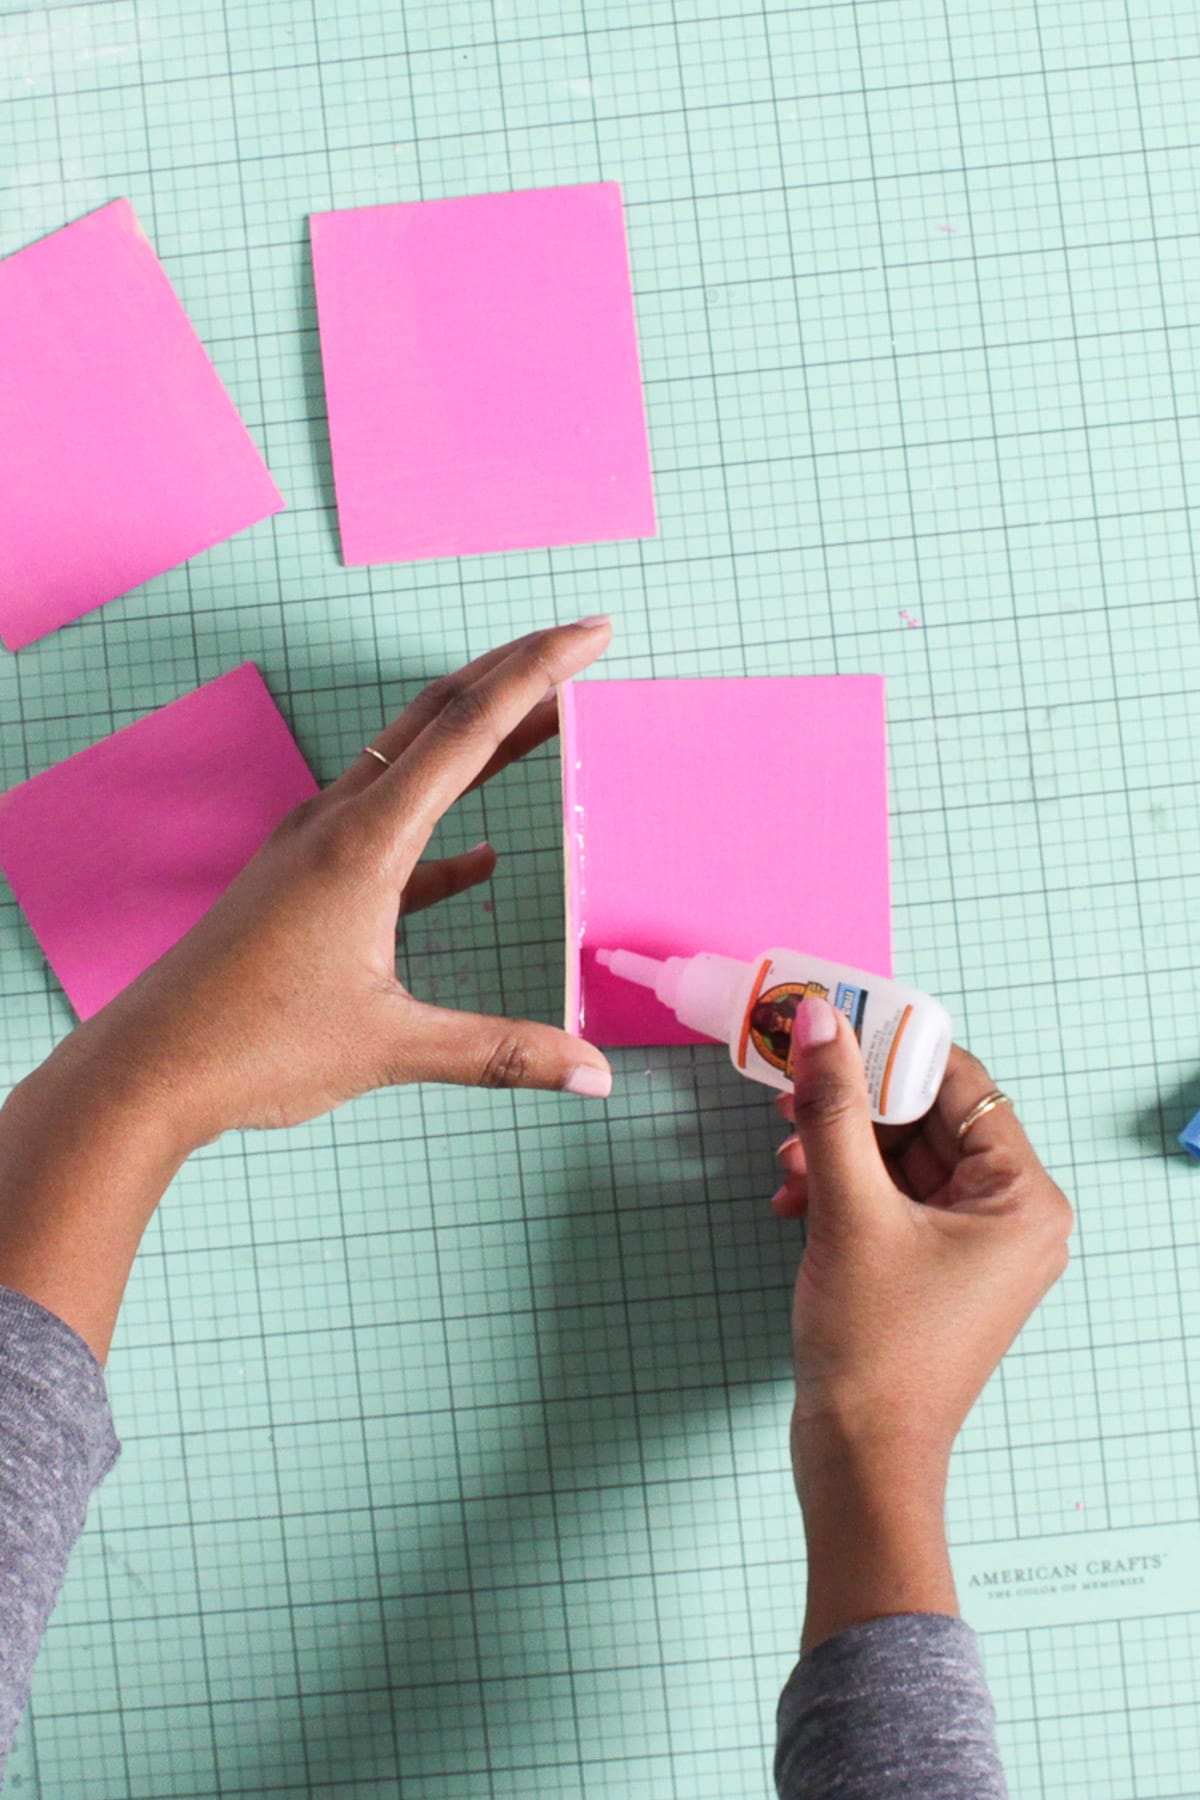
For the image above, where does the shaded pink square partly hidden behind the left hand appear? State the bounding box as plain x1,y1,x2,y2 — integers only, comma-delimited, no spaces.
0,662,317,1019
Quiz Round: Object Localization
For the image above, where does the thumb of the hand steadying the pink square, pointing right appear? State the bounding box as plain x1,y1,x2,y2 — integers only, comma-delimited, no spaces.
401,1001,612,1100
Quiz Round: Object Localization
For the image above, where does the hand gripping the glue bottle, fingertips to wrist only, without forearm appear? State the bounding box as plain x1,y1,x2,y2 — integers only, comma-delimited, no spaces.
775,1001,1070,1449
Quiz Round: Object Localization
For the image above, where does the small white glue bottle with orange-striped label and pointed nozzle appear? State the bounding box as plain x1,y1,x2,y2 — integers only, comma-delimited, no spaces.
596,950,954,1125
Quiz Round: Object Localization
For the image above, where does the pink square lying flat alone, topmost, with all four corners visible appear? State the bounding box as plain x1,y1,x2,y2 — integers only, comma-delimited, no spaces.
311,182,655,563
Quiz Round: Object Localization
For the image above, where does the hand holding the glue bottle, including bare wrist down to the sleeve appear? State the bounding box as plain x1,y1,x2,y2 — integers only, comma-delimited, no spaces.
774,999,1072,1645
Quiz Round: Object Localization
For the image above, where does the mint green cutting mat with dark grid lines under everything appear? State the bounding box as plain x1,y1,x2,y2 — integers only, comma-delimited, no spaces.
0,0,1200,1800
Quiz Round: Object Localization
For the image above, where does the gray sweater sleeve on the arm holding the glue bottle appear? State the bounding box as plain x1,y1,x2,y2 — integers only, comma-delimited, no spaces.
775,1613,1007,1800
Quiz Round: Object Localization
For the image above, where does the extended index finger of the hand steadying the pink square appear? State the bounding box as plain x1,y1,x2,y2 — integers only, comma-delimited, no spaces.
354,617,612,855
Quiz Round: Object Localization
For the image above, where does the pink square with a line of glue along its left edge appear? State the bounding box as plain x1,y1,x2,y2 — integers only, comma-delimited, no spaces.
561,675,892,1046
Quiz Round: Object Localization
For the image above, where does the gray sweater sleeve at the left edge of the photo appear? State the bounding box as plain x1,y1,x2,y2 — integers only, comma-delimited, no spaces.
0,1287,119,1777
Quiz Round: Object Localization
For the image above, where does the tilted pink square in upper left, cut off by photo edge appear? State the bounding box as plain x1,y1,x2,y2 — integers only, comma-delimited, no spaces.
0,200,284,650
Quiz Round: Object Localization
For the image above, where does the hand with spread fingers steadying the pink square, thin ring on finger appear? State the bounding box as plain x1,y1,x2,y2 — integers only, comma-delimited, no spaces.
43,619,612,1150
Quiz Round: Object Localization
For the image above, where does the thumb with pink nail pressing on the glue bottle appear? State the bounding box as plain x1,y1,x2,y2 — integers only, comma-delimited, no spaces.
790,995,887,1219
